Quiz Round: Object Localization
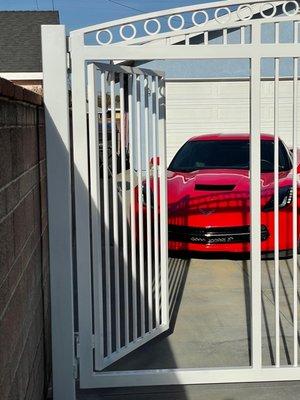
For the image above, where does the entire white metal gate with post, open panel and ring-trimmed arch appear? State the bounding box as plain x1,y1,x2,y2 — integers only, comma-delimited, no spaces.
43,0,300,399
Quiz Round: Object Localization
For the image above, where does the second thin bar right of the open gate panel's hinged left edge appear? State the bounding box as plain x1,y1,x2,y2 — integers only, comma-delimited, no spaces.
110,72,121,350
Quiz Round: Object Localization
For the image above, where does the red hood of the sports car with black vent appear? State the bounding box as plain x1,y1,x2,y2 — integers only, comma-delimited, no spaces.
167,169,292,209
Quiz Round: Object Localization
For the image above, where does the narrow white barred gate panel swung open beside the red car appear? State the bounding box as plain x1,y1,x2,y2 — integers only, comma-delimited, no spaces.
88,63,169,370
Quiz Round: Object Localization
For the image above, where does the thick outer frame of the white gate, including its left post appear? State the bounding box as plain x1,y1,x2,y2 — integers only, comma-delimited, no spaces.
42,0,300,400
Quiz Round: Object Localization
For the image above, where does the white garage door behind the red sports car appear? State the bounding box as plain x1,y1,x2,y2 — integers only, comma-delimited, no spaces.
166,80,300,162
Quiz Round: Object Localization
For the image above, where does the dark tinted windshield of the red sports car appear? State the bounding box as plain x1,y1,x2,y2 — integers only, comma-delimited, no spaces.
169,140,292,172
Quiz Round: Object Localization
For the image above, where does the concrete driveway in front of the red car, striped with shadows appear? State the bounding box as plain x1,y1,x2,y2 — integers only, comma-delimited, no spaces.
78,259,300,400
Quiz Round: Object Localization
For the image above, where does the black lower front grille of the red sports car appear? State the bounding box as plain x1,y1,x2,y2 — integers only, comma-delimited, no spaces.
168,225,270,244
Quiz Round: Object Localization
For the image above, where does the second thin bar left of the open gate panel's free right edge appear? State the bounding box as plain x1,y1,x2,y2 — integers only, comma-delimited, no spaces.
145,77,153,331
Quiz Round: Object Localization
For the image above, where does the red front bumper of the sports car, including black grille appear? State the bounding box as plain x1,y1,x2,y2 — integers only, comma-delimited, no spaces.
168,207,299,253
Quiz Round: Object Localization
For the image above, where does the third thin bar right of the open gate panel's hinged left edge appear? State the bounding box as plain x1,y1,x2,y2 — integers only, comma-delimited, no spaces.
120,73,129,346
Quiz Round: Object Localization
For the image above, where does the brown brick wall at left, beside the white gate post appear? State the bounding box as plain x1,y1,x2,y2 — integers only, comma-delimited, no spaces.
0,79,50,400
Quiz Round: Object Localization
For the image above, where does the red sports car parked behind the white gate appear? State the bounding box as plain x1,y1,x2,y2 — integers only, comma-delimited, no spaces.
167,134,300,254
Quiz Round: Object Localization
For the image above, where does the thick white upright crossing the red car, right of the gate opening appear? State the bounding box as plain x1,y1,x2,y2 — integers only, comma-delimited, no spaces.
250,57,262,369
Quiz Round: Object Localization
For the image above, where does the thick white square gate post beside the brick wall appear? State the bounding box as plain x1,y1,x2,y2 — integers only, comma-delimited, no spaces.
42,25,76,400
